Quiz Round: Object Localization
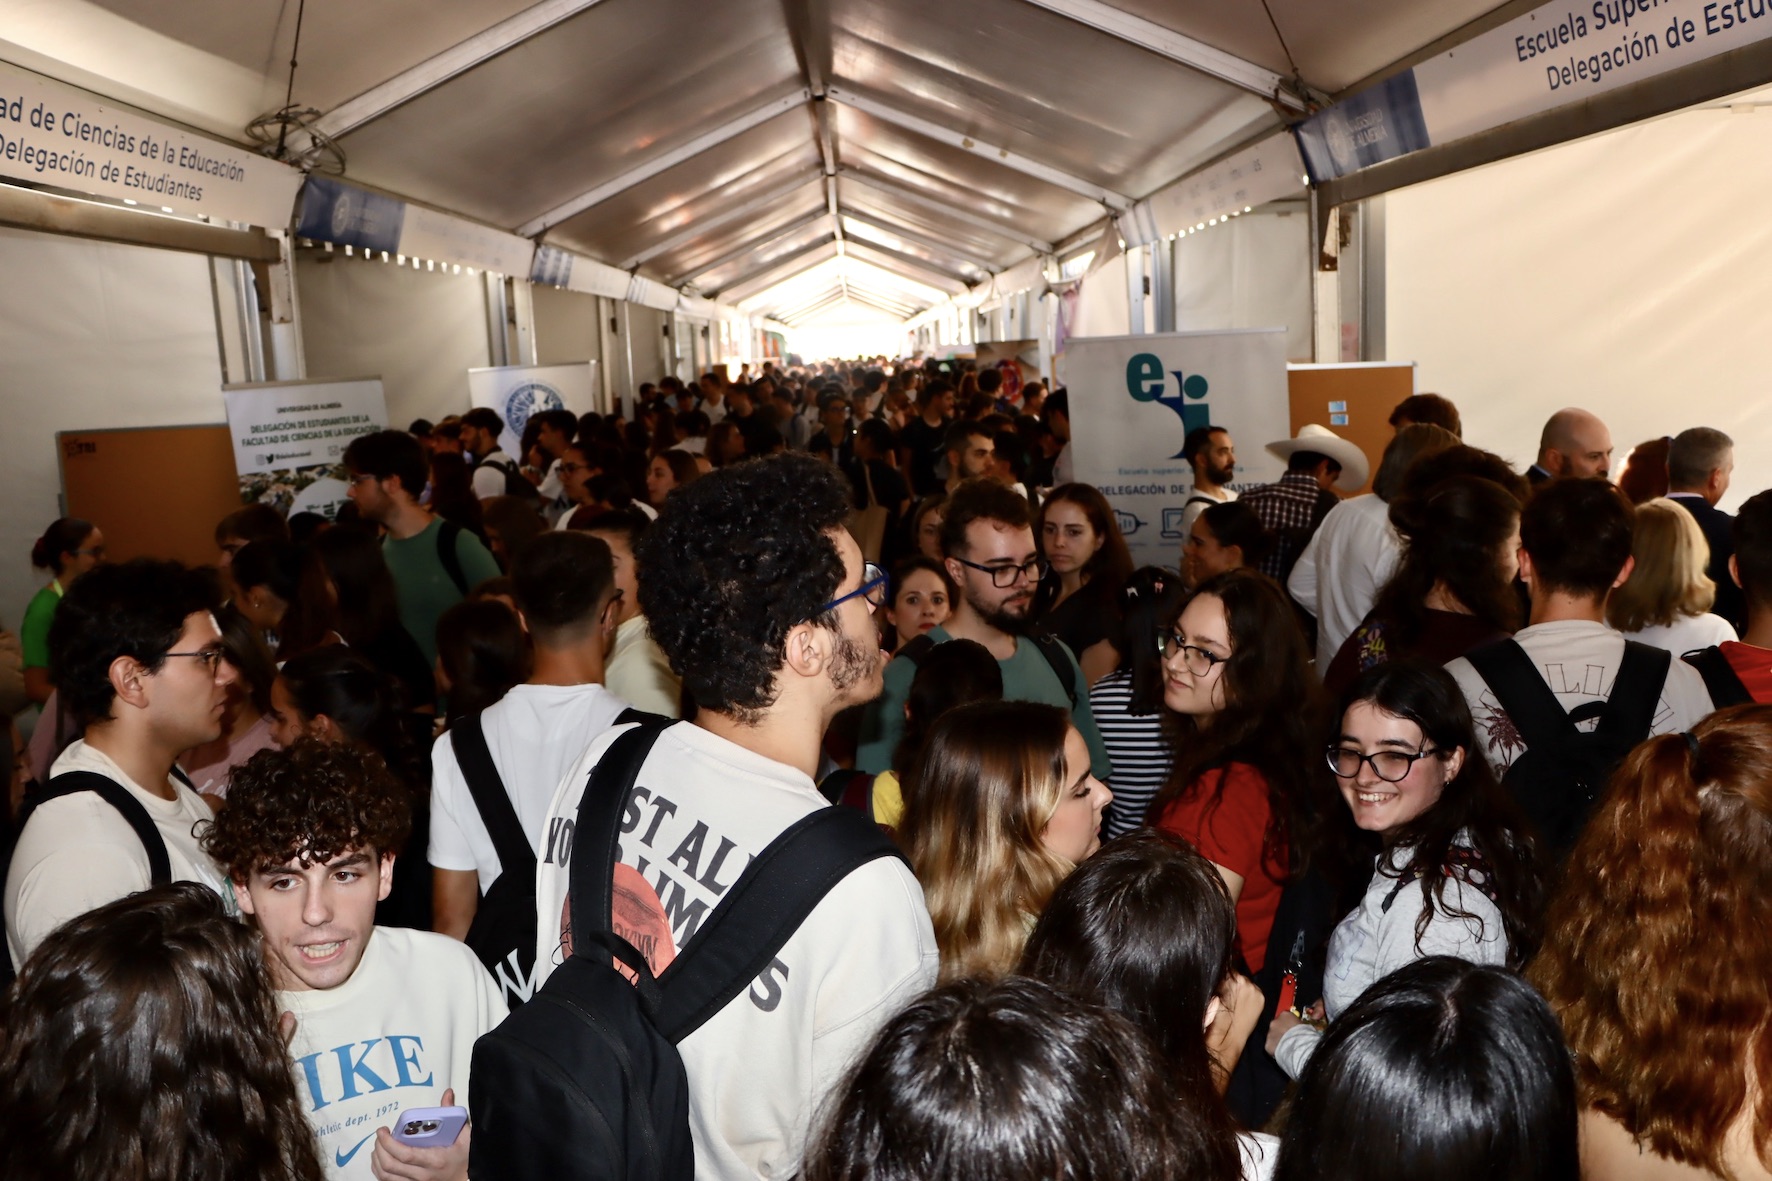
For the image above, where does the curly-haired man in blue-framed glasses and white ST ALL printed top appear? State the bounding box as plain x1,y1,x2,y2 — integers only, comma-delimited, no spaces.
535,454,937,1177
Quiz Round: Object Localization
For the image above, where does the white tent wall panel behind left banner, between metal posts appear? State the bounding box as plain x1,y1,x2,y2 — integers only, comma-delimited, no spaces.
296,250,492,427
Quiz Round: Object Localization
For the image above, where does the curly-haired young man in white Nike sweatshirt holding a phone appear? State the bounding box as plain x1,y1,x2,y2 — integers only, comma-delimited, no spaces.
202,739,505,1181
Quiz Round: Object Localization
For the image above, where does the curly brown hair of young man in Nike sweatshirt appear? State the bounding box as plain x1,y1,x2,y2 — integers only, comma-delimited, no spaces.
200,739,413,881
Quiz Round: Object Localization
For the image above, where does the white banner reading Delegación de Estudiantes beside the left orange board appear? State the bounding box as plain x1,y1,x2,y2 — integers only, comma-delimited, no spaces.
222,378,388,521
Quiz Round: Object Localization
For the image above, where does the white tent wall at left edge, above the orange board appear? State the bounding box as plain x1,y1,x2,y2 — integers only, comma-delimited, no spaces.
0,229,223,631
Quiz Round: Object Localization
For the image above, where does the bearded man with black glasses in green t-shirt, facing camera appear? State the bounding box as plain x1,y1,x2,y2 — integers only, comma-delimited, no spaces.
856,479,1111,780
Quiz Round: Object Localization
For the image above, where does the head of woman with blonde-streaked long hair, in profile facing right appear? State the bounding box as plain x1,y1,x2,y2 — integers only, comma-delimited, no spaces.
898,700,1113,981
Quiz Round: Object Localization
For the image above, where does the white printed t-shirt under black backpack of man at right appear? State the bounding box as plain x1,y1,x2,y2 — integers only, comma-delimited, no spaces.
1446,619,1712,775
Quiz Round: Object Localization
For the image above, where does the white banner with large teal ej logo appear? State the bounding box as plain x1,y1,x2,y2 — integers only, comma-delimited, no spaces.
1065,328,1292,569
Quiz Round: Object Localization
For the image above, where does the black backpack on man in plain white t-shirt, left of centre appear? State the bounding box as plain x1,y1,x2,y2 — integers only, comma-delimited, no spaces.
448,709,668,1009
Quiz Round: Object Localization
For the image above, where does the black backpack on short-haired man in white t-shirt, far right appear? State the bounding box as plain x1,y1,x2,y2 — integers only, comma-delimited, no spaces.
1469,640,1673,862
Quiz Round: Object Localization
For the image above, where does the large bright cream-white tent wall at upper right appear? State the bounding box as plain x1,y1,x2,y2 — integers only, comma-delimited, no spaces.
1386,102,1772,509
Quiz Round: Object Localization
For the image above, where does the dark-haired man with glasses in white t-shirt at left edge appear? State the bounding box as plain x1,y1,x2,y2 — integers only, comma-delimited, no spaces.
5,559,236,968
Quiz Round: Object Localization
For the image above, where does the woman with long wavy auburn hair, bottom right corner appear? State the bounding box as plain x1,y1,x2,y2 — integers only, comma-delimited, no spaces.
1527,706,1772,1181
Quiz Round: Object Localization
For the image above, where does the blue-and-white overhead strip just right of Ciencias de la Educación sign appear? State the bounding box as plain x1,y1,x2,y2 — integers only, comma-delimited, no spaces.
296,176,535,277
